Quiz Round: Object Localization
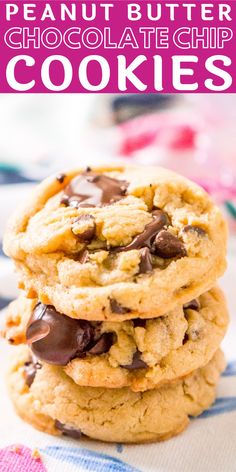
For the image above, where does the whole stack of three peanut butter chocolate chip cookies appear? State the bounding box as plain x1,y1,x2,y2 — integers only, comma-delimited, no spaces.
4,167,228,443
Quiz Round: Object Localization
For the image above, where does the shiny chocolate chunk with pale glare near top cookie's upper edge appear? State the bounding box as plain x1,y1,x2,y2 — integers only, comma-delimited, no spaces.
61,170,129,208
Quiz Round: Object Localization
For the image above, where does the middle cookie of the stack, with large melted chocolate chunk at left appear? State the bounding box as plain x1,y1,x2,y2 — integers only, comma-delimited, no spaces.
5,287,228,391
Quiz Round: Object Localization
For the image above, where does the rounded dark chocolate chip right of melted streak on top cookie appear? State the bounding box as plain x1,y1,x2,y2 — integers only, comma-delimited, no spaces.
154,230,187,259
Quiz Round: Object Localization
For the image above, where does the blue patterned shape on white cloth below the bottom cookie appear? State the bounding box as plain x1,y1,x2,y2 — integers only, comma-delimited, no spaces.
41,446,140,472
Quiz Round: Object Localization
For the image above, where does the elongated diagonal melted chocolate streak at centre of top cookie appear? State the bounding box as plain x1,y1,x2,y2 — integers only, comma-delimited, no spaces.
114,210,169,252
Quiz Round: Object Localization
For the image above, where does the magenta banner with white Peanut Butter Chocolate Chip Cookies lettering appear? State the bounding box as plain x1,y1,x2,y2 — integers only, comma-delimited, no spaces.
0,0,236,93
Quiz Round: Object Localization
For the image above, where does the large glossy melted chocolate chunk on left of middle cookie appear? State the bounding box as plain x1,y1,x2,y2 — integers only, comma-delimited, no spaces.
26,303,94,365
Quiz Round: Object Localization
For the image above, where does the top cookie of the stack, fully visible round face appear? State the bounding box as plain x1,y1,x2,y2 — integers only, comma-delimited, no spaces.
4,167,227,321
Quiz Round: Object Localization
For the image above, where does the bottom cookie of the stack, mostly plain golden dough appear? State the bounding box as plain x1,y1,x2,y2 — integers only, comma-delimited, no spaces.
8,347,225,443
